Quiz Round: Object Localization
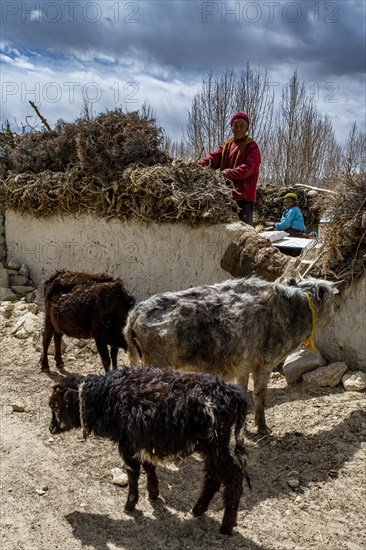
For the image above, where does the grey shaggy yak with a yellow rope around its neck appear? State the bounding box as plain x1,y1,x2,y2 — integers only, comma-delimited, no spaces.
125,277,338,433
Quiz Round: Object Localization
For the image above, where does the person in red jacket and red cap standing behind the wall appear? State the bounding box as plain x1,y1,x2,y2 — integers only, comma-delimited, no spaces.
197,113,261,225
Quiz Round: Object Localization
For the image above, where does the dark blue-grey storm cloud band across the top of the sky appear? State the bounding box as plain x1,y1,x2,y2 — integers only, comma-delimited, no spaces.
1,0,365,78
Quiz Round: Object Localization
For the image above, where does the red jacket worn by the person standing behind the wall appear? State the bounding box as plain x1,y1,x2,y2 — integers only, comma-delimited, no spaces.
198,136,261,202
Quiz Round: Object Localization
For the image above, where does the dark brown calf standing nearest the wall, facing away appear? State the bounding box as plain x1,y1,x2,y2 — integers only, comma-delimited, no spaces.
40,271,135,372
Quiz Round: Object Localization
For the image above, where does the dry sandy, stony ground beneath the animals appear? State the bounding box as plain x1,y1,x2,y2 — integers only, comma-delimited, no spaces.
0,302,366,550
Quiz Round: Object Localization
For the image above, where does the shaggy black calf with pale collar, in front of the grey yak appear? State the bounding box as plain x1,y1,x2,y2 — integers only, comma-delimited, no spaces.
49,367,249,535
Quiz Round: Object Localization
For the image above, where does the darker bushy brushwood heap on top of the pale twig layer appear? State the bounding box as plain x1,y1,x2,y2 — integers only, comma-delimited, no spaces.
0,109,170,183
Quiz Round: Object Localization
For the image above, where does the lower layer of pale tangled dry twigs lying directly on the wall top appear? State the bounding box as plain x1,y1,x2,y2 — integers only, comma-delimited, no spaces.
0,162,238,225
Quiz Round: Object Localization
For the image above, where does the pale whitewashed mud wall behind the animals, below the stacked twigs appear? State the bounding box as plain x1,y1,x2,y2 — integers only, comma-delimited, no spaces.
5,211,251,300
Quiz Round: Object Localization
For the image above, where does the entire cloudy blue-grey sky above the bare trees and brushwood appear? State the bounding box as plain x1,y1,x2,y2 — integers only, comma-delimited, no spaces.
0,0,366,140
